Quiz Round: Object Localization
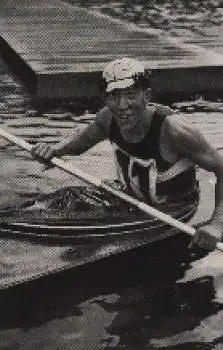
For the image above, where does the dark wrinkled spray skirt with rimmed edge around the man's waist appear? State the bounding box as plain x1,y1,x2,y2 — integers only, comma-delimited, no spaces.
0,186,198,244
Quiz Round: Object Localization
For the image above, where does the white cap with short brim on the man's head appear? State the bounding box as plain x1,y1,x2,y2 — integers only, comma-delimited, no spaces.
103,57,145,92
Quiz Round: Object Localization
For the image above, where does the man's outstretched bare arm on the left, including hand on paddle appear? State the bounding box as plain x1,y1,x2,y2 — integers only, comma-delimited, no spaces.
31,107,111,162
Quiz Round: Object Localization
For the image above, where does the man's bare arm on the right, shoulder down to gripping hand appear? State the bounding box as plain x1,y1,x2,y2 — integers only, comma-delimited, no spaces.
165,114,223,249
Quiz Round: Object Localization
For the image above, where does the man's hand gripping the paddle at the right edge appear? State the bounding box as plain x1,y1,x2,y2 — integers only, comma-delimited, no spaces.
189,223,223,251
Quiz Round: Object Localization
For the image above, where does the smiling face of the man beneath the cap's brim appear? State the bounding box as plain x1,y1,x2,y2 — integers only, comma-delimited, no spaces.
105,86,146,131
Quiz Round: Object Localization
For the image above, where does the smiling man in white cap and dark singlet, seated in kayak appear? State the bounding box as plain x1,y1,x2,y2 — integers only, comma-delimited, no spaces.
32,58,223,250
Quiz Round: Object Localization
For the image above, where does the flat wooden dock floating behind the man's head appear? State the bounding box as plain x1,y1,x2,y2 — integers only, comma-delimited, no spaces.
0,0,223,99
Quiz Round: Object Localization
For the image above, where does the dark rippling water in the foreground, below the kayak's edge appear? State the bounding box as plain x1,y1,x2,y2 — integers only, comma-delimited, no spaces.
0,238,223,350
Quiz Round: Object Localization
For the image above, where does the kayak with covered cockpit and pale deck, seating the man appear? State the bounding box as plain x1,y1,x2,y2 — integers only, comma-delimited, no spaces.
0,181,214,290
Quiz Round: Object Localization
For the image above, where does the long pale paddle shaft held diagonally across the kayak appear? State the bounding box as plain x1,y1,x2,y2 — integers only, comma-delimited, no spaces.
0,128,223,251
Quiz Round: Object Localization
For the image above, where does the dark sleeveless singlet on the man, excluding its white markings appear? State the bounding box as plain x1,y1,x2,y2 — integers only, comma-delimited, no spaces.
109,110,198,202
